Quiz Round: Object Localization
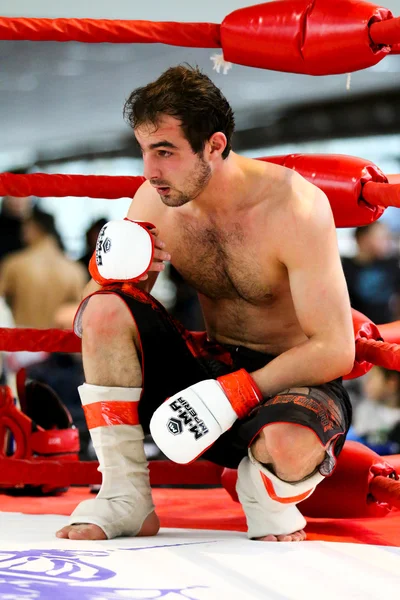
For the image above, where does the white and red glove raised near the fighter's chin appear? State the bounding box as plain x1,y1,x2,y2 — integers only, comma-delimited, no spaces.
89,219,155,285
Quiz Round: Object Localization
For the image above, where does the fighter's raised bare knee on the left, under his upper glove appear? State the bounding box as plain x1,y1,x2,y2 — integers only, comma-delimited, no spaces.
82,294,136,344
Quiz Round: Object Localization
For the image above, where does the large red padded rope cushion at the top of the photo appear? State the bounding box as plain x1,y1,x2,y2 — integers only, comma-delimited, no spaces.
220,0,393,75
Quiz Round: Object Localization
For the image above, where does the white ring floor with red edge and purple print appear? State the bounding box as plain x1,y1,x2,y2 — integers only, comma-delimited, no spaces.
0,488,400,600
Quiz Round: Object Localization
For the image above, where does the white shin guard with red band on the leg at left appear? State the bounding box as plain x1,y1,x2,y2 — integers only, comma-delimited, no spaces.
69,383,154,539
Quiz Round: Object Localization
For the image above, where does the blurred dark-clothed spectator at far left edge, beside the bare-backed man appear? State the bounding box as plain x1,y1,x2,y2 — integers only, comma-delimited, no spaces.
0,196,32,260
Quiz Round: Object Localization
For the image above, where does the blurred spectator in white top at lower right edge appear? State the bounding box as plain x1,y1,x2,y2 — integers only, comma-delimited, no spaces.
348,367,400,454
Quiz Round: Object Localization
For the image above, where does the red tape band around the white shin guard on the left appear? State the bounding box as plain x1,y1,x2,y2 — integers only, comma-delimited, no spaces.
83,400,140,429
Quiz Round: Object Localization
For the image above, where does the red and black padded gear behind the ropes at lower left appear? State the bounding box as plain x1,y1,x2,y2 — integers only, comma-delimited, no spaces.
0,381,79,494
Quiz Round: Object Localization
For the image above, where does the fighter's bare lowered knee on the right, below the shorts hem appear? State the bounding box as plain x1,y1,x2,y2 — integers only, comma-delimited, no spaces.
252,423,325,482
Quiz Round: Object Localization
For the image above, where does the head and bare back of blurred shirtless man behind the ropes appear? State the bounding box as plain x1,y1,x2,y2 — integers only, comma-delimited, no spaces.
0,207,86,328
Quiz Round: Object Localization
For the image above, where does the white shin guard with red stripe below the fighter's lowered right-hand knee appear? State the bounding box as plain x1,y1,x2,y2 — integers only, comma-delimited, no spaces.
236,449,324,538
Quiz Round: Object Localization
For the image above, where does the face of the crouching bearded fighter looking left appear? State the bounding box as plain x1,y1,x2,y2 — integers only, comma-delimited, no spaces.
135,115,212,206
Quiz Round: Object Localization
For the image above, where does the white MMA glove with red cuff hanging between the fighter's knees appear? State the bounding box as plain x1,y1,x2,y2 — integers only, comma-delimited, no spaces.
150,369,262,464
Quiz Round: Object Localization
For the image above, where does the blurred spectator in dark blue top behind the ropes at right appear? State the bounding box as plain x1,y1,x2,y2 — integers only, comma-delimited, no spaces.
342,221,400,324
